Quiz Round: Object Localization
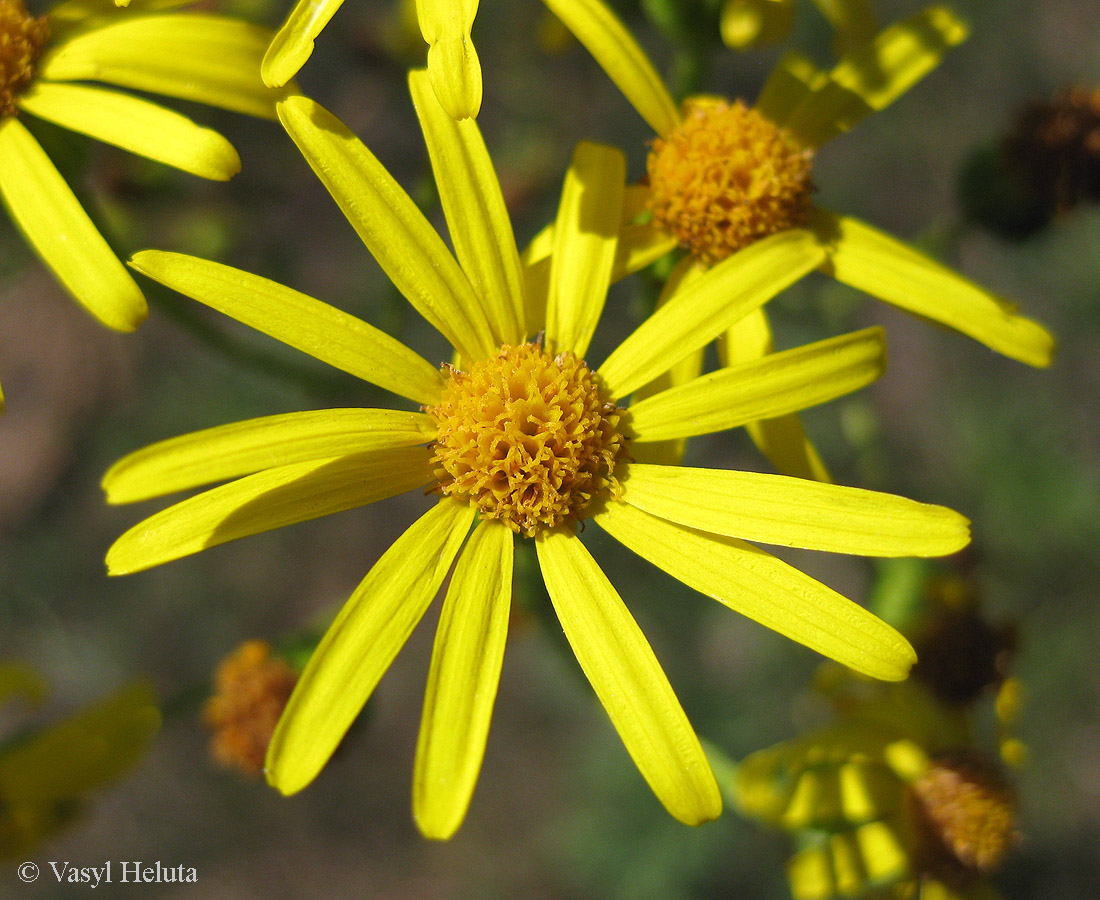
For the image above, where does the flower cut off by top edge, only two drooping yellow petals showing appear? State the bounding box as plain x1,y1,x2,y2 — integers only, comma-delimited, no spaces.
262,0,482,119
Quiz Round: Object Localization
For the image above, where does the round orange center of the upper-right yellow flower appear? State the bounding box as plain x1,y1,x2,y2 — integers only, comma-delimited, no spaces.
647,98,813,265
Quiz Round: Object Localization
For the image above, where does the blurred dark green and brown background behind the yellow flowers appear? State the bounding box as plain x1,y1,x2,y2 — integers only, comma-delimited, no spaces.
0,0,1100,900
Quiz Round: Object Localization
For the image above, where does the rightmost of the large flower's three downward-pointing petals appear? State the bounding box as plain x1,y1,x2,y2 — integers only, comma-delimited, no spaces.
536,529,722,825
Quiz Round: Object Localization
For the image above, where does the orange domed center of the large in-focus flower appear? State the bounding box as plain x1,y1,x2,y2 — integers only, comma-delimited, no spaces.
426,343,625,536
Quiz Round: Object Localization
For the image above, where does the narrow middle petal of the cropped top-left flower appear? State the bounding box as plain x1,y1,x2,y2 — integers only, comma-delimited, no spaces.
19,81,241,182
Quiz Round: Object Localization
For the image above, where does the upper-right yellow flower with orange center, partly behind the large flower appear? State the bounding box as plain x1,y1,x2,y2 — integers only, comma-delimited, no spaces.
536,0,1054,366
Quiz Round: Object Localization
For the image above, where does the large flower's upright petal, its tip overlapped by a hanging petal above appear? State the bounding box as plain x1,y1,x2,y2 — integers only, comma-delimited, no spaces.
409,69,526,344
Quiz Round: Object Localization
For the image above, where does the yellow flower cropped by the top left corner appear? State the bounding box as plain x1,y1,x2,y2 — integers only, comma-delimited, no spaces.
0,0,285,341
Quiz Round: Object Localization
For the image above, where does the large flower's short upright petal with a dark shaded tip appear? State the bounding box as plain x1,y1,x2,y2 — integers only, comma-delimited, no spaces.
546,142,626,359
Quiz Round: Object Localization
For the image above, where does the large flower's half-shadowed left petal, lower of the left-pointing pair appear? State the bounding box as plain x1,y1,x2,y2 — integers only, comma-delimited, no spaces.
107,447,433,575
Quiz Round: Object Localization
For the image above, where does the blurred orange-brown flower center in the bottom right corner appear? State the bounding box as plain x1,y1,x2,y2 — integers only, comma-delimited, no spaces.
911,754,1016,874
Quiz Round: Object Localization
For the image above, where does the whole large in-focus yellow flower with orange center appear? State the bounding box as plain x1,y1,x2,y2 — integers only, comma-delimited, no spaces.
103,77,969,838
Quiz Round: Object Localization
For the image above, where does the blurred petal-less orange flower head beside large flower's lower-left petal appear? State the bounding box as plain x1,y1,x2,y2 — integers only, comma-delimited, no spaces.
202,640,298,776
